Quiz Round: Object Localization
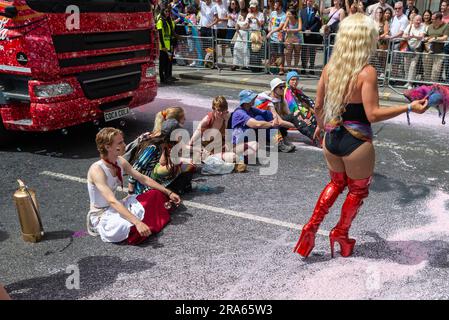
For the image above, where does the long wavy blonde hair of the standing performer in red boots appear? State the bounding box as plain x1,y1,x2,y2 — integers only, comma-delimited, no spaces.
324,13,379,123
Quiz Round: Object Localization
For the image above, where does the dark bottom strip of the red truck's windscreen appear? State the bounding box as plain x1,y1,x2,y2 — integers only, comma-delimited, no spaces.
26,0,151,13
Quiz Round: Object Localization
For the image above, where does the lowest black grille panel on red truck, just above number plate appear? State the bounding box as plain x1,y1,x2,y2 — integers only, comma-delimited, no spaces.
76,64,142,99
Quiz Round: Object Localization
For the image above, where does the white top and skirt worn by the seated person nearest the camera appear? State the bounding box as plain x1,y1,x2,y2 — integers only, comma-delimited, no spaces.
87,160,145,242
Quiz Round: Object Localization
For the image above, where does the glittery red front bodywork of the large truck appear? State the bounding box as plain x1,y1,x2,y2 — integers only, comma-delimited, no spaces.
0,0,158,131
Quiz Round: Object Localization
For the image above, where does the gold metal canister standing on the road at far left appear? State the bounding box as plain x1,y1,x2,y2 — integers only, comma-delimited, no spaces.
14,180,44,242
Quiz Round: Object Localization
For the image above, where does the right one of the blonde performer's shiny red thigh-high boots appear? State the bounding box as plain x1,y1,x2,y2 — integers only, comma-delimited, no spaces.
329,177,371,257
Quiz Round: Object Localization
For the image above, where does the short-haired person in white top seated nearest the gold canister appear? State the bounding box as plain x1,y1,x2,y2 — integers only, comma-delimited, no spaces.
87,127,181,245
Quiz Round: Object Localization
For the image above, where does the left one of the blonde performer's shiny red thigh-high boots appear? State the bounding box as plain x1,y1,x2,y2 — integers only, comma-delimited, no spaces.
294,171,347,257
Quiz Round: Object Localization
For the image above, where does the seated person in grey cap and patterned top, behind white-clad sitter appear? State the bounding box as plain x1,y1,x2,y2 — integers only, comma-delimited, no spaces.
128,119,196,194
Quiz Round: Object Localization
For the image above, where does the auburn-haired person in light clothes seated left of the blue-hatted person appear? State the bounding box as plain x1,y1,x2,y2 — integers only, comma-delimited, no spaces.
190,96,257,163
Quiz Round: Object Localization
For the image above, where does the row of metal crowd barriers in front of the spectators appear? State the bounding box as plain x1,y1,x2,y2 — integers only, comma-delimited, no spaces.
175,26,449,87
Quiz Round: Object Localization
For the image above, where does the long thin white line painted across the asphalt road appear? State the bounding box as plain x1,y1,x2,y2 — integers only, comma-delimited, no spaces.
40,171,329,236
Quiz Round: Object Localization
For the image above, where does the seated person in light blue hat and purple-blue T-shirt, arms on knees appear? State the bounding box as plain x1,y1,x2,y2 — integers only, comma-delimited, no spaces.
231,90,278,150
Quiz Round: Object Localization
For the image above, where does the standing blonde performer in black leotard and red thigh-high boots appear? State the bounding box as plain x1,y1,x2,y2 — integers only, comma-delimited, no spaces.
294,13,427,257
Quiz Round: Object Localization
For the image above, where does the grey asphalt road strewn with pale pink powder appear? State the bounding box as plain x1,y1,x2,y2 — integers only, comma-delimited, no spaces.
0,81,449,299
